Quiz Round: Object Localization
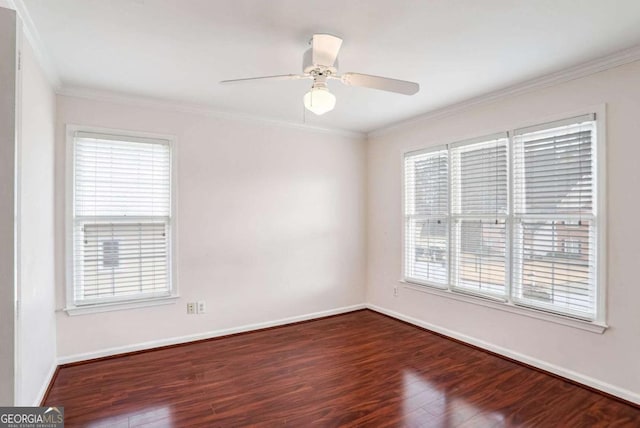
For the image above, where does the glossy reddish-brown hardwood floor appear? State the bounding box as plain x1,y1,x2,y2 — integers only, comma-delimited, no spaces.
46,310,640,427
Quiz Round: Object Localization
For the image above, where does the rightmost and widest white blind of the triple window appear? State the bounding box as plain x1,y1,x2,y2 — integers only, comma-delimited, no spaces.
513,116,597,318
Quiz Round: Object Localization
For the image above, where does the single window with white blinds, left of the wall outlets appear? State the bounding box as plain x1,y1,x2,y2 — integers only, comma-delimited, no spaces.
71,131,172,306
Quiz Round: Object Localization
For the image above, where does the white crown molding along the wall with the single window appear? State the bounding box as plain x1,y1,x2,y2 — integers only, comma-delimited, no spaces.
56,86,367,140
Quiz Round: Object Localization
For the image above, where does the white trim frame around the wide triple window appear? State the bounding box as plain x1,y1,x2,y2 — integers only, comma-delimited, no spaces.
399,104,608,334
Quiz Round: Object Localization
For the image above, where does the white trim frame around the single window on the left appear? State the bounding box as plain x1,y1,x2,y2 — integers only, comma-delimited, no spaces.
64,124,179,315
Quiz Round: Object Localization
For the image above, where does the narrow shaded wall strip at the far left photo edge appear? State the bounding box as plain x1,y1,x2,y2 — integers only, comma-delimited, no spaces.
0,8,16,406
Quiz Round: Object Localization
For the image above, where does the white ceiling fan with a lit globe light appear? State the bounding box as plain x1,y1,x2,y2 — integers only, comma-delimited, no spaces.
220,34,420,115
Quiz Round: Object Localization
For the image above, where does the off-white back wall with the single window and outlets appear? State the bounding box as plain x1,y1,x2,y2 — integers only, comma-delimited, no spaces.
56,96,366,359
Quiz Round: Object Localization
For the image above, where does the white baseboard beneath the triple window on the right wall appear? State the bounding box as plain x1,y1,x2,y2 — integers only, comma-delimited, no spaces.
365,303,640,404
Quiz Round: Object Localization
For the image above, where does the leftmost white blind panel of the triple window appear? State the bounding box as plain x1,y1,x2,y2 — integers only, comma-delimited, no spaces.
405,150,449,287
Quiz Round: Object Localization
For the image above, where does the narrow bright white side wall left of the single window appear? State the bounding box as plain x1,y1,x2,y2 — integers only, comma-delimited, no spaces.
16,39,56,406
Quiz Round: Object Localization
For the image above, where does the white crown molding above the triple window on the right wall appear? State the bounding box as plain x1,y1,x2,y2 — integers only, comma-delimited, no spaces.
367,45,640,138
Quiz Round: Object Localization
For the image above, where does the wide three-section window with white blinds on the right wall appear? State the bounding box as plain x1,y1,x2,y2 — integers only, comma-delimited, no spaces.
404,115,601,321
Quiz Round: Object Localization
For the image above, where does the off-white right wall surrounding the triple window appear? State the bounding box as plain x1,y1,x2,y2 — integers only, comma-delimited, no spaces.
367,62,640,403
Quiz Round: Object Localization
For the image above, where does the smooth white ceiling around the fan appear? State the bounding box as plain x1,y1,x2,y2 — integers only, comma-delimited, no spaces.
23,0,640,132
